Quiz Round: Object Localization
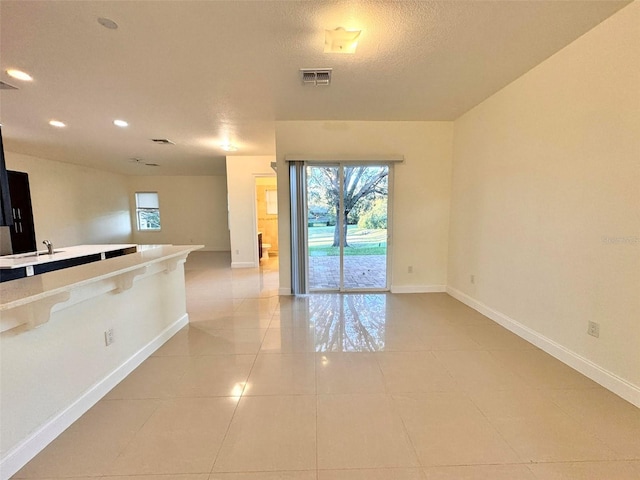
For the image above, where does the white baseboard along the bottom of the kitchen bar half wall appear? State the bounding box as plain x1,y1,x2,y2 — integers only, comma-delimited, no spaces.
0,313,189,480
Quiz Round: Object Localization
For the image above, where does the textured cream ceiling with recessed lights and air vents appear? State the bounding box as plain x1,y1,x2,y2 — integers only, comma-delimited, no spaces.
0,0,628,175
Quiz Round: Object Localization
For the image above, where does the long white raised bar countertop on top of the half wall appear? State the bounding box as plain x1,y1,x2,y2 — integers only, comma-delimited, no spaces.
0,245,204,311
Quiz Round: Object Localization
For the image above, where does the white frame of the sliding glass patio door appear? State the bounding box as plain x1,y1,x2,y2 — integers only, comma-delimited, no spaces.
303,161,394,293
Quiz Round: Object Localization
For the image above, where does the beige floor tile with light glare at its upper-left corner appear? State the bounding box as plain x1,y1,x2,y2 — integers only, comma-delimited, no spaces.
214,395,316,472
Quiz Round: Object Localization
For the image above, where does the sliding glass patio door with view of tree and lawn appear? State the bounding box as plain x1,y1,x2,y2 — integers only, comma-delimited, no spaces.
305,163,390,292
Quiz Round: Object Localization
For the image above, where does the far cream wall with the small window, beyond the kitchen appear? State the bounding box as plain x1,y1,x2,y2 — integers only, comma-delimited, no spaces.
128,176,230,251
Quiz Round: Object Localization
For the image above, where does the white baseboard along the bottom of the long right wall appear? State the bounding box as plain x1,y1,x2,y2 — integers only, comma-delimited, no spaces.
447,287,640,407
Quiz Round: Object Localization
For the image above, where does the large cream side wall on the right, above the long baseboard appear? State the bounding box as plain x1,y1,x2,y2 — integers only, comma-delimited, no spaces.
449,2,640,404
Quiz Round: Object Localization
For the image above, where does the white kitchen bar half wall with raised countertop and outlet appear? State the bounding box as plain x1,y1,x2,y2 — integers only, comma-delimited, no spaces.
0,245,202,479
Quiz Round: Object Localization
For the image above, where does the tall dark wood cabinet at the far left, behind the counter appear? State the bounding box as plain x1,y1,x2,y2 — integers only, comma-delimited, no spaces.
7,170,37,254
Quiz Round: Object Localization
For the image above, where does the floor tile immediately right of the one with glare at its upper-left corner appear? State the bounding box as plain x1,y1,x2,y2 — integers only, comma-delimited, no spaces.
318,394,418,470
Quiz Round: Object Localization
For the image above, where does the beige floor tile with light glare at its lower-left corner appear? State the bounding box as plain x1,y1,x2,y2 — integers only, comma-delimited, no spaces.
245,353,316,395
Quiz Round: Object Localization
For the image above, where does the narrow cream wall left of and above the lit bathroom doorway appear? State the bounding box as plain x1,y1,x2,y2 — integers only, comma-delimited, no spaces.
227,155,280,268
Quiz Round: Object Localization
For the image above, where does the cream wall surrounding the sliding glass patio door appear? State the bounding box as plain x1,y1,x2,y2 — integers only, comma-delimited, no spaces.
276,121,453,293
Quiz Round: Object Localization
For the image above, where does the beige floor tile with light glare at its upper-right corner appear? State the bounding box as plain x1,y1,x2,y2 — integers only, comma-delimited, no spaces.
109,397,237,475
